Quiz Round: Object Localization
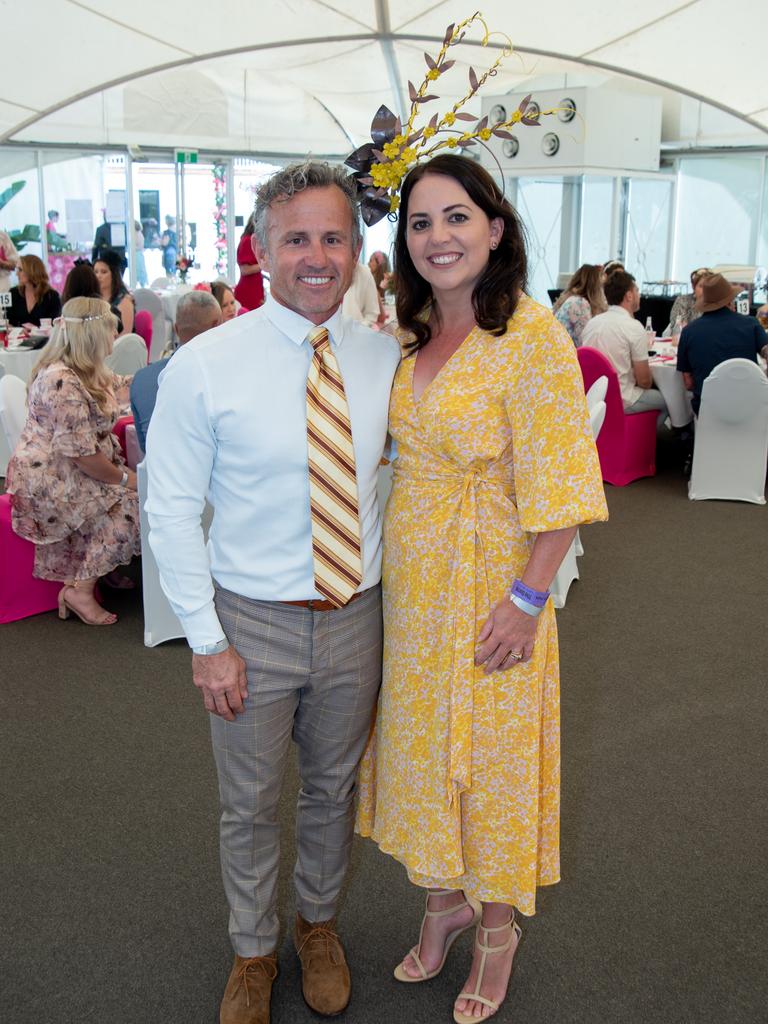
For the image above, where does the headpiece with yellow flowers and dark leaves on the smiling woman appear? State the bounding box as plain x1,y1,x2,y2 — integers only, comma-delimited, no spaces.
345,11,557,227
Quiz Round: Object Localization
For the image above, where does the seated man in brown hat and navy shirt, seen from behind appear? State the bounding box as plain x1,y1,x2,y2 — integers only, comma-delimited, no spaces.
677,273,768,416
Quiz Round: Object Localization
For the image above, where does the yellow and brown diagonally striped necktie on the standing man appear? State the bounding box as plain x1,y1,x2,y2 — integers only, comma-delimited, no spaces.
306,328,362,608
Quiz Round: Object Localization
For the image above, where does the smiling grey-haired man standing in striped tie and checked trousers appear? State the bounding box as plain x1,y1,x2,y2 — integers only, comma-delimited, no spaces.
146,162,399,1024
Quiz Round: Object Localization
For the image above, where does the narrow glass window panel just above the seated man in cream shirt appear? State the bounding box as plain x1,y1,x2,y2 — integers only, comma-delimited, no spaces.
625,178,672,291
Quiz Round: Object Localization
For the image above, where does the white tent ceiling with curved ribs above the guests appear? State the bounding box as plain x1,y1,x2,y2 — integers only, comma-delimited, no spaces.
0,0,768,156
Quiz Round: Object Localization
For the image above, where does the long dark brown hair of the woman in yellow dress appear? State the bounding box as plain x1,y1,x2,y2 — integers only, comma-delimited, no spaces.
394,156,527,352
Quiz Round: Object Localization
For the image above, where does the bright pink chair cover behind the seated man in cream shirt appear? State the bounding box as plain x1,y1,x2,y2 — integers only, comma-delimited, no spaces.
577,345,658,487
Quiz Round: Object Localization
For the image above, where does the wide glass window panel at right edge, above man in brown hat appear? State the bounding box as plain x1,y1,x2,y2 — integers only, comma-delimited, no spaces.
674,156,762,281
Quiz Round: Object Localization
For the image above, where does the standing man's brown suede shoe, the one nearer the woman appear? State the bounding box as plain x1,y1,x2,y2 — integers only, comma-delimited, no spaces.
296,913,352,1017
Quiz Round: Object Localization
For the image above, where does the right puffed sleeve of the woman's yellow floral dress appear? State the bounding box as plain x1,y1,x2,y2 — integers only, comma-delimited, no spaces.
506,310,608,534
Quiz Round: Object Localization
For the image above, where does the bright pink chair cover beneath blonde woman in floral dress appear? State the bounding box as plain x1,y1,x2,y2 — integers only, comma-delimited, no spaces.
0,495,61,623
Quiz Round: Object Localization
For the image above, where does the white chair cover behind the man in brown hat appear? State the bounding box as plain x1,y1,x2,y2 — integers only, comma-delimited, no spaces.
688,359,768,505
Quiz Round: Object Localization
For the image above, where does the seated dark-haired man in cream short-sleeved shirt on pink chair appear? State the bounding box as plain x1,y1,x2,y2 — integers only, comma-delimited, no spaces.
582,270,667,421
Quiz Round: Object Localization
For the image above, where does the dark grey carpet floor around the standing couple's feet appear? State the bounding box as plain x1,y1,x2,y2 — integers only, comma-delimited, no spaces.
0,436,768,1024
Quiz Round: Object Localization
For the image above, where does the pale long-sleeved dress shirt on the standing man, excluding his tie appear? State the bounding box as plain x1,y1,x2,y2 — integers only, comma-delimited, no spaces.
146,297,400,647
